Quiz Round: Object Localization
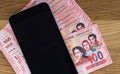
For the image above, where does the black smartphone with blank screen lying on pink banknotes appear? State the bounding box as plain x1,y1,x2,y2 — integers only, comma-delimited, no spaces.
9,3,77,74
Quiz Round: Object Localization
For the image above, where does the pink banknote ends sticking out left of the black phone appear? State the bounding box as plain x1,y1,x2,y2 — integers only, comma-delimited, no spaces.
0,25,31,74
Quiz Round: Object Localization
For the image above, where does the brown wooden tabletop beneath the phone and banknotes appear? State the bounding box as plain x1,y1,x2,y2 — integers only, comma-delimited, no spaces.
0,0,120,74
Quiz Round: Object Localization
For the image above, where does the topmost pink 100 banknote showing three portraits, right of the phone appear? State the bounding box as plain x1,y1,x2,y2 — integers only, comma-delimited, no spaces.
64,24,112,74
